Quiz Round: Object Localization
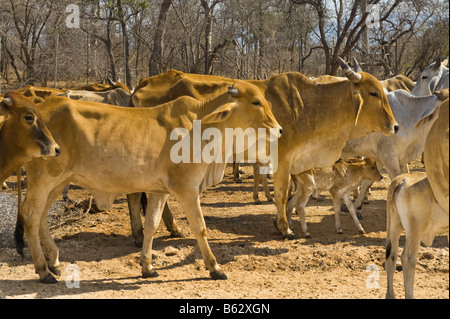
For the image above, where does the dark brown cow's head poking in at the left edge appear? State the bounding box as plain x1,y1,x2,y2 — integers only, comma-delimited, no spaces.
0,91,60,161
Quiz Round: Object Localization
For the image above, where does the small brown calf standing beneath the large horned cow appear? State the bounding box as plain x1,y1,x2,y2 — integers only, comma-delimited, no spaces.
287,158,382,238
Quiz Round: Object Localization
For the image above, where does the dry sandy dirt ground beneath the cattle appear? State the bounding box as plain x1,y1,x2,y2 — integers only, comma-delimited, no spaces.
0,163,449,299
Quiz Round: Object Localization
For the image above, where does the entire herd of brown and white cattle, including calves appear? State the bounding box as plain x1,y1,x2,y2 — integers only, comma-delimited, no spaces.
0,59,449,298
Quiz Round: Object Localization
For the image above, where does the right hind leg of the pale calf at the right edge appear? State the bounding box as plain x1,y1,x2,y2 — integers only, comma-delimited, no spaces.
401,232,422,299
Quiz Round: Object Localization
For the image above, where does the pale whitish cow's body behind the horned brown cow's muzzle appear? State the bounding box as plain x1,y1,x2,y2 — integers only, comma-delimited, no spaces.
342,90,442,208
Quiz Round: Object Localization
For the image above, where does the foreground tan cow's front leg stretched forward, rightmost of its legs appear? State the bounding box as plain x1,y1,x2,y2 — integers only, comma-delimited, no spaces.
177,194,227,280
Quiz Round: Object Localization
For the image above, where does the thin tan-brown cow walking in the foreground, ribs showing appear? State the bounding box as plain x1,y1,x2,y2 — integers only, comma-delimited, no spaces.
15,82,281,283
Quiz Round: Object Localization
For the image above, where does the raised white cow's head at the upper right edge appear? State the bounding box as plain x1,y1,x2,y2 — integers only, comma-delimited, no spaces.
411,57,448,96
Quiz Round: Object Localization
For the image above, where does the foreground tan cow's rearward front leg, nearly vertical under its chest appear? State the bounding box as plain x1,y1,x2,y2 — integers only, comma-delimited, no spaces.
141,193,169,278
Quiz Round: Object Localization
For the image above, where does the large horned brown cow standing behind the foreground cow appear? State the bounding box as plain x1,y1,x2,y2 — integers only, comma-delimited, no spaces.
132,60,399,238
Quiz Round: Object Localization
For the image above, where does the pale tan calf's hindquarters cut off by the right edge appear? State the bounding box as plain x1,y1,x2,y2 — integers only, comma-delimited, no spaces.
386,172,448,298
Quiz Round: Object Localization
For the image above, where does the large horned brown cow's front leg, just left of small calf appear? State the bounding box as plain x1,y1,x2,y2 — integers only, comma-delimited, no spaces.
273,163,297,239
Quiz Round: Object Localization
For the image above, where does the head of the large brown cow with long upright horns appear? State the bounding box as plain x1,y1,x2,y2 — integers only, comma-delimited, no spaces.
339,58,399,135
